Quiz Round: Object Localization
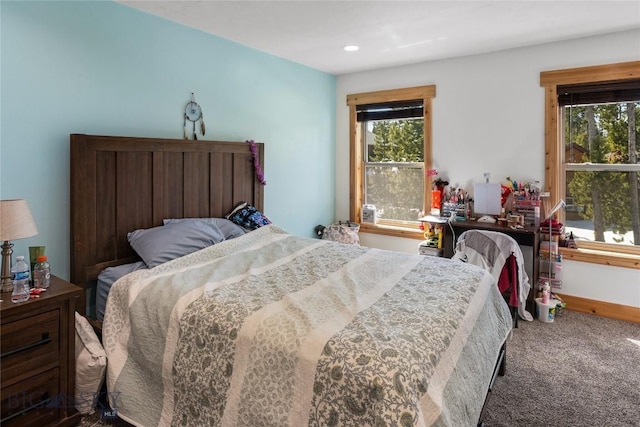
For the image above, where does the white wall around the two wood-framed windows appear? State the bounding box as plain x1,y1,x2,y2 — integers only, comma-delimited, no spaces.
336,30,640,307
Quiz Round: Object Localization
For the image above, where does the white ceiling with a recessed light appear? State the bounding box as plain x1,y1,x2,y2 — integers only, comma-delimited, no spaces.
117,0,640,75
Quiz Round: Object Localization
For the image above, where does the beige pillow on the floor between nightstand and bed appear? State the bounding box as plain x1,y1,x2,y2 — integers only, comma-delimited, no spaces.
74,312,107,414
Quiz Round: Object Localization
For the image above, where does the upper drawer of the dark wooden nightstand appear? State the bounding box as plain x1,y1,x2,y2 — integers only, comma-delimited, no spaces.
0,310,60,386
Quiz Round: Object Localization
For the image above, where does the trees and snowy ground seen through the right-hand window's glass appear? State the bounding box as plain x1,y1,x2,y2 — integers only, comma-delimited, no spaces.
563,99,640,245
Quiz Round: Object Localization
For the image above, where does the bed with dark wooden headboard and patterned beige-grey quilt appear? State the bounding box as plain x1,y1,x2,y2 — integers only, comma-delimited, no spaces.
71,135,511,426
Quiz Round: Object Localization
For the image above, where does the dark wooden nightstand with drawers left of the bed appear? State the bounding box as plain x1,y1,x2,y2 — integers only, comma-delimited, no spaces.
0,275,81,427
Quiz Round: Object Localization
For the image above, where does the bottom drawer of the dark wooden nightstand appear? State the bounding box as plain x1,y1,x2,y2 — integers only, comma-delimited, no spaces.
0,369,59,427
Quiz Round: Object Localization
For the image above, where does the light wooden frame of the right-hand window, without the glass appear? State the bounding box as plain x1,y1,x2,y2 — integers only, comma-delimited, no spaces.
540,61,640,269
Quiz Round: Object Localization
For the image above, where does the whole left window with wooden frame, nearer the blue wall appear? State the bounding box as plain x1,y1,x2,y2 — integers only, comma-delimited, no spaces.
347,86,435,237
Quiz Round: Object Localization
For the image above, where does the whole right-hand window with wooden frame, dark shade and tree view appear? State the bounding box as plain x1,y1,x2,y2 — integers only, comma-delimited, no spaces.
540,61,640,268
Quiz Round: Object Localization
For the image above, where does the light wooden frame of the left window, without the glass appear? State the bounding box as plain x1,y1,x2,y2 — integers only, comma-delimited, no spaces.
347,85,436,239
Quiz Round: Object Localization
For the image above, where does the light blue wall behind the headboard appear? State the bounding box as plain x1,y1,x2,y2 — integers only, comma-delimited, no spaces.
0,1,336,278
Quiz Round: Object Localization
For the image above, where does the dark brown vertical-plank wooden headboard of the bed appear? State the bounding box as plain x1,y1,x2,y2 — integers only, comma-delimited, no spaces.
70,134,264,314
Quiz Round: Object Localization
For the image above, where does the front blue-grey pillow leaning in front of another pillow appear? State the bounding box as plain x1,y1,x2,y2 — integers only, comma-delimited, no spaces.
127,221,224,268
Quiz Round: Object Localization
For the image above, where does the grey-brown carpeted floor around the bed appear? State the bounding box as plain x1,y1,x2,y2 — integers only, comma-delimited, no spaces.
81,310,640,427
